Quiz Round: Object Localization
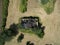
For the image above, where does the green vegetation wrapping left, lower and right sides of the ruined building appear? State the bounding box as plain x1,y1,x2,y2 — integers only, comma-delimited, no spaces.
17,17,45,38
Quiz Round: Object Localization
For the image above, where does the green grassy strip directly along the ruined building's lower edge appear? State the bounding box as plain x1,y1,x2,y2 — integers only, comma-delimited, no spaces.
20,29,44,38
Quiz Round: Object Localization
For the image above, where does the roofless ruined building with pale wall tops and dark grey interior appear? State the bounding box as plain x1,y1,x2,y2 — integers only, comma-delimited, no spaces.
21,16,39,28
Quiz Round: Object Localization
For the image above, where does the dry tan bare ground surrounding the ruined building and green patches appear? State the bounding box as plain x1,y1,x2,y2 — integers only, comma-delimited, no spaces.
6,0,60,45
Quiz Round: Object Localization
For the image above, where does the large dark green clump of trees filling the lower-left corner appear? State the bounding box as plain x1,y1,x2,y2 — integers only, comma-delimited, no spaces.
0,24,18,45
